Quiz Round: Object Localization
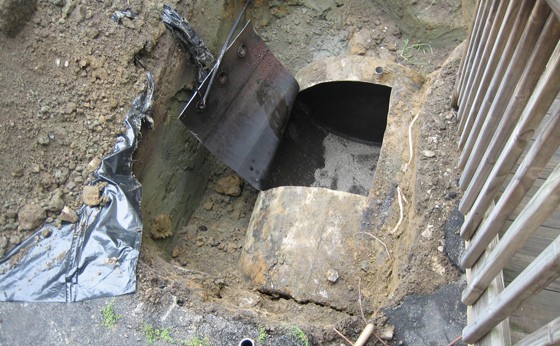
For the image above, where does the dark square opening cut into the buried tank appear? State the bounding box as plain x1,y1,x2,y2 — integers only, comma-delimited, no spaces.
266,81,391,195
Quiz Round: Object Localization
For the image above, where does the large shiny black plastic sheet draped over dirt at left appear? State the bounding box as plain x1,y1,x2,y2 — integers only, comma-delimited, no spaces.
0,73,154,302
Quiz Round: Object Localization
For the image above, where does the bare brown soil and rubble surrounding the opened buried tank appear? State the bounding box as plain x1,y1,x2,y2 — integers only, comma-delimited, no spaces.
0,0,466,344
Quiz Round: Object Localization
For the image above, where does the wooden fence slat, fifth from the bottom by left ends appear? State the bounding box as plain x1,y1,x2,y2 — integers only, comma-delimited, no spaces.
459,13,560,219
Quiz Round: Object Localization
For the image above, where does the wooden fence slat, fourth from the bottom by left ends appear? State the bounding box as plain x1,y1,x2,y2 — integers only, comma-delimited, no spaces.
459,36,560,239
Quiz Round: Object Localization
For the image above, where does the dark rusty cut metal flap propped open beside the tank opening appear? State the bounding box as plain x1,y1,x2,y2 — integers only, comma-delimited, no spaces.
180,25,299,189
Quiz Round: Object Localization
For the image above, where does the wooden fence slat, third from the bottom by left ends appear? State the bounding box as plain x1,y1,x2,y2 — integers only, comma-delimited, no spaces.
461,105,560,268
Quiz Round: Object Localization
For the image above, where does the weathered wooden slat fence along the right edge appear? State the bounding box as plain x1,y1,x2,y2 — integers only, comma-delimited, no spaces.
453,0,560,345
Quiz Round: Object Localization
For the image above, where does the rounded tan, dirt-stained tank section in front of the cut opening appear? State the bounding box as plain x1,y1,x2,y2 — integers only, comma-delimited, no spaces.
236,187,389,311
